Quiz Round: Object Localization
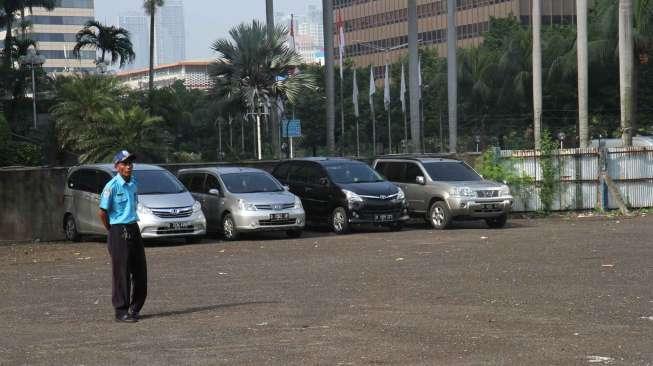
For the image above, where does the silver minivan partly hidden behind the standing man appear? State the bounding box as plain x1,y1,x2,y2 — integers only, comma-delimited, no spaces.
63,164,206,242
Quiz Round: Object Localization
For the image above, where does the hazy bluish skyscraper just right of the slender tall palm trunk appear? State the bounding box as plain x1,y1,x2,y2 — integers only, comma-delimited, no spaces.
157,0,186,65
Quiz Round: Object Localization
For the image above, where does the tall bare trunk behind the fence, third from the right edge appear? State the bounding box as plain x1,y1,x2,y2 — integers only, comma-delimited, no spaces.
533,0,542,150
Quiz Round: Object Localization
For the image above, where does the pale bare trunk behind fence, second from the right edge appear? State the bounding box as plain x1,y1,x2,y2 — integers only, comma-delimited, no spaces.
576,0,589,148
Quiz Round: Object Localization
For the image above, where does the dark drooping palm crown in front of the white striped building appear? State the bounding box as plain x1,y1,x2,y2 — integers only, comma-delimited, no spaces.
73,20,136,67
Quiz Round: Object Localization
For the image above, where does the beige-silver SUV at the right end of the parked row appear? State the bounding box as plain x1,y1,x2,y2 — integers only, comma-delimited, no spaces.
373,157,513,229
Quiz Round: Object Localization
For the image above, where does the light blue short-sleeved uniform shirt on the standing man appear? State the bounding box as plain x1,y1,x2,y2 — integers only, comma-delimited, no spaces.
100,174,138,225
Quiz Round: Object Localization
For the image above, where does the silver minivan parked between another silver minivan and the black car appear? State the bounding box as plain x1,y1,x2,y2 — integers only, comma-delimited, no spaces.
177,167,305,240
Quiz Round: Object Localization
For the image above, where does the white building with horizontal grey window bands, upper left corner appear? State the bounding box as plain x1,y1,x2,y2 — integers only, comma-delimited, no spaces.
0,0,96,72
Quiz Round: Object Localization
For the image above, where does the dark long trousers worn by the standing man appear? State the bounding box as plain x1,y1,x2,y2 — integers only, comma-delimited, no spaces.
107,223,147,315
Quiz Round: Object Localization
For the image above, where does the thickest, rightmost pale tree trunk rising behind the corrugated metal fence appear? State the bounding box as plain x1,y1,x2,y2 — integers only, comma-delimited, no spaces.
619,0,634,146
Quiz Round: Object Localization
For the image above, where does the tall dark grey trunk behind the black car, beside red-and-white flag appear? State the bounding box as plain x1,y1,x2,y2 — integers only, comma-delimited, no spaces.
322,0,336,155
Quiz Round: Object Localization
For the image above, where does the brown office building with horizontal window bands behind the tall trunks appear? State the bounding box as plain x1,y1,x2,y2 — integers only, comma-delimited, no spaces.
333,0,576,76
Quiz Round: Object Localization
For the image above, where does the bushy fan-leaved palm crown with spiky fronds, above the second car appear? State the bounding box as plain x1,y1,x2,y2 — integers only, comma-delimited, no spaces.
210,20,316,159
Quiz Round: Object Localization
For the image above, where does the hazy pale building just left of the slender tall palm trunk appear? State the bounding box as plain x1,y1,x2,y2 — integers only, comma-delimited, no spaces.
118,13,150,69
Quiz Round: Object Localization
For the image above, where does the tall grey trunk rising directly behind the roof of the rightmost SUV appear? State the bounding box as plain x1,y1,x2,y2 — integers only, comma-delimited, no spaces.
408,0,423,153
